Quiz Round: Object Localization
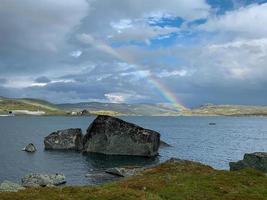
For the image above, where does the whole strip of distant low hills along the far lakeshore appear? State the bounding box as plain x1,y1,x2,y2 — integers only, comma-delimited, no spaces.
0,97,267,116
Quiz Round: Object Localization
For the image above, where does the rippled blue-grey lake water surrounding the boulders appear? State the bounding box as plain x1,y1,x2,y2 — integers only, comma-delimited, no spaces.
0,117,267,184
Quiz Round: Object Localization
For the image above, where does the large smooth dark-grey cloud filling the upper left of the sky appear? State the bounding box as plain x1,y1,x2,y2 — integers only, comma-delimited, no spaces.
0,0,88,75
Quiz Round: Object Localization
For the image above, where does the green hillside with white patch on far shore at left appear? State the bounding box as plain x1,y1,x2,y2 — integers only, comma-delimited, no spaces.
0,97,65,115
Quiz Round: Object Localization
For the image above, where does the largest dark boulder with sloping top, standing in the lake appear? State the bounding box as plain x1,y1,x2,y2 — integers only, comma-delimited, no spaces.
83,115,160,157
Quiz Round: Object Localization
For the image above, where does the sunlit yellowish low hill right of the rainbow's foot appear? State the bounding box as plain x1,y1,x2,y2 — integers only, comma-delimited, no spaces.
181,104,267,116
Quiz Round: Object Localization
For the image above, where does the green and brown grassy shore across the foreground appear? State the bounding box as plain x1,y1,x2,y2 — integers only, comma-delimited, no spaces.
0,161,267,200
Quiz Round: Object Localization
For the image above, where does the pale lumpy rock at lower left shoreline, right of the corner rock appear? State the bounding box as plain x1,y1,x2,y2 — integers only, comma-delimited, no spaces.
21,173,66,187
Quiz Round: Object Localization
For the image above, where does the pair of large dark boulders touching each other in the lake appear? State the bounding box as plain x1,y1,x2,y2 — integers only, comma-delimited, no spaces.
44,115,160,157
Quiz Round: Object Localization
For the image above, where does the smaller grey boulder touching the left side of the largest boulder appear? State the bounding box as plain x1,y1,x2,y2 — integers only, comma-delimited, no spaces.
44,128,83,150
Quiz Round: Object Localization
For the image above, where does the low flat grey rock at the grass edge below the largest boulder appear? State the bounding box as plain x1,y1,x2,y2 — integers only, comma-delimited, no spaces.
105,167,145,177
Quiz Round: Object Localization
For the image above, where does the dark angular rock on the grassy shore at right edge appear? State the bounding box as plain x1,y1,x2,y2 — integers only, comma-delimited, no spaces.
229,152,267,173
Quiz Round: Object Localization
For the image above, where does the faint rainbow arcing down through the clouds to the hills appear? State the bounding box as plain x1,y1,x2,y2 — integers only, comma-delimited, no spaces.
86,35,186,111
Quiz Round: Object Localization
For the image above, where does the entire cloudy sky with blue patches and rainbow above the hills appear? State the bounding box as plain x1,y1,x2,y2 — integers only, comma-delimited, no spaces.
0,0,267,107
